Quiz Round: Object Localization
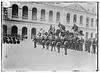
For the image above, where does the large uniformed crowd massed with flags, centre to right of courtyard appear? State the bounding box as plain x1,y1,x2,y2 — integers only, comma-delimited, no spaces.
33,23,97,55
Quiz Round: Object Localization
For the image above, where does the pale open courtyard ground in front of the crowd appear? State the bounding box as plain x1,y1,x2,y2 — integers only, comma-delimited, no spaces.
2,40,97,71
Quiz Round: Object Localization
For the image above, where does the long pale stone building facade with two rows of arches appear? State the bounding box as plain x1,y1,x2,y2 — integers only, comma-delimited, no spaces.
2,2,97,39
